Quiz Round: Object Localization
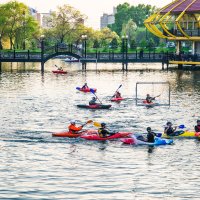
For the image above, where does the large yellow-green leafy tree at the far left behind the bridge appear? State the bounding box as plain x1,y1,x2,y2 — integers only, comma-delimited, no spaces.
0,1,39,49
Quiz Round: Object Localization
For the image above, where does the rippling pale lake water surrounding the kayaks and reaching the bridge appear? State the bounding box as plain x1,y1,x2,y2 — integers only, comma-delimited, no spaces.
0,60,200,200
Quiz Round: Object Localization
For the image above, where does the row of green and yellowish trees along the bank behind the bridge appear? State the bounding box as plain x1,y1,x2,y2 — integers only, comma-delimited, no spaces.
0,1,164,51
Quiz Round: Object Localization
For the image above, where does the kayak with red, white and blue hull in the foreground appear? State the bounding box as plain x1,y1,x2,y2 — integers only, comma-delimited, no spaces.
120,137,173,145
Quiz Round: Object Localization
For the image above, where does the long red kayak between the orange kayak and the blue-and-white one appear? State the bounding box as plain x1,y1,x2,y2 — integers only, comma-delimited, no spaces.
81,131,132,141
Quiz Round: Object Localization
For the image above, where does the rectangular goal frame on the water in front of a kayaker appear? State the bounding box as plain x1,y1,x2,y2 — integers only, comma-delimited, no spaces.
135,82,170,106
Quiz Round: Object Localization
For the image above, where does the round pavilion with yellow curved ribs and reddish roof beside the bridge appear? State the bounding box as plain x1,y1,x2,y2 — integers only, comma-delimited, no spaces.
144,0,200,65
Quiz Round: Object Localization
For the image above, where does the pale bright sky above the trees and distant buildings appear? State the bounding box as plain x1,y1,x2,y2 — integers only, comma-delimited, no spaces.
0,0,172,29
